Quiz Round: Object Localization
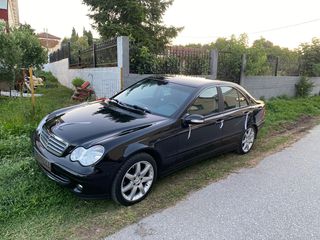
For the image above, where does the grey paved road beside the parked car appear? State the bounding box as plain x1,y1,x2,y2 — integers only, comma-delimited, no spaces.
107,126,320,240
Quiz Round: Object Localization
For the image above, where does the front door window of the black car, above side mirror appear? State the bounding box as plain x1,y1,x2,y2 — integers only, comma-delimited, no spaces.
188,87,219,116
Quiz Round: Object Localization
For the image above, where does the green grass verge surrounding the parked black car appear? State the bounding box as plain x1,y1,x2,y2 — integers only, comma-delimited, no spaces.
0,83,320,239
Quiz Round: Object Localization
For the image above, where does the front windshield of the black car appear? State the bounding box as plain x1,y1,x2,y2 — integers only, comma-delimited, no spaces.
113,79,195,117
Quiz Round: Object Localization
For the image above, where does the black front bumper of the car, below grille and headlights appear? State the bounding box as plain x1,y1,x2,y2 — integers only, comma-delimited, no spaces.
32,134,120,198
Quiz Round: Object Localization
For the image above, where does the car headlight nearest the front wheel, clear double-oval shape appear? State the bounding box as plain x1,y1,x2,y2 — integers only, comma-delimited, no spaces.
70,145,104,166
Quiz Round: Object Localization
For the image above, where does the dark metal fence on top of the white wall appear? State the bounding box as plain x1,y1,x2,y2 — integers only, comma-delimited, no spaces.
49,38,118,68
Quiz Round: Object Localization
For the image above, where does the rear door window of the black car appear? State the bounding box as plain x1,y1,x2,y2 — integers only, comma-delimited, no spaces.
221,87,248,110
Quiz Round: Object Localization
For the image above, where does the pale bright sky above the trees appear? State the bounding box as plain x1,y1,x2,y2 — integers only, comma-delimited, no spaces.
18,0,320,49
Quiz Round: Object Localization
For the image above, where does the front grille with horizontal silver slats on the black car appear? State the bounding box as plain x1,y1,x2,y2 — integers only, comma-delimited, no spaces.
40,127,68,156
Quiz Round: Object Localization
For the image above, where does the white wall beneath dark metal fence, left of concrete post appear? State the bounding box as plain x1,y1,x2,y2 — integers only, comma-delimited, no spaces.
44,59,121,98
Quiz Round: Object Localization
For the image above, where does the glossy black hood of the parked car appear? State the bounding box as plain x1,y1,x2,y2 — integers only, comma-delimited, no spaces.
45,102,167,146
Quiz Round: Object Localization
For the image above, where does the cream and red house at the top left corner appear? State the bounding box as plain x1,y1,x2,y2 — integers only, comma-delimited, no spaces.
0,0,19,27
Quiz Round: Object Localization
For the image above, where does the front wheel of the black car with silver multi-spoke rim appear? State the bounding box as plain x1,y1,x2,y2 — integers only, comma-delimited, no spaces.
111,153,157,206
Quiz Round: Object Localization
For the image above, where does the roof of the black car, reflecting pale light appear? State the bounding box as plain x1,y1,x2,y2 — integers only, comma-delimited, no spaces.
150,75,239,88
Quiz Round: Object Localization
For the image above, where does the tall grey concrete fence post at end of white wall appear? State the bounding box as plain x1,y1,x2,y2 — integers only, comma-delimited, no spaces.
117,36,130,77
